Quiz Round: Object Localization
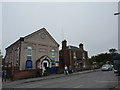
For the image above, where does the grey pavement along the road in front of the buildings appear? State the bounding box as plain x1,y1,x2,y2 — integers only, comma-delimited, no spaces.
2,69,100,87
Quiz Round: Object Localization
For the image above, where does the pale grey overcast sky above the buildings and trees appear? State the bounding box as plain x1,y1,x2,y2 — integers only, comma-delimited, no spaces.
0,2,118,56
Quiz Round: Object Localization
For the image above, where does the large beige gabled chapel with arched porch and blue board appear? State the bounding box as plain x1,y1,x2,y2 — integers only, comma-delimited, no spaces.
5,28,59,79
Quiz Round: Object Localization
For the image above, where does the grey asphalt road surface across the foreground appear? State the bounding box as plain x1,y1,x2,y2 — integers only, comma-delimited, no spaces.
3,71,120,88
